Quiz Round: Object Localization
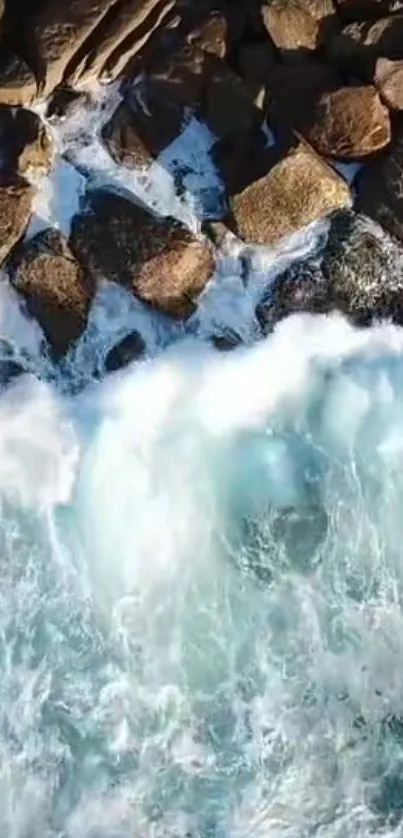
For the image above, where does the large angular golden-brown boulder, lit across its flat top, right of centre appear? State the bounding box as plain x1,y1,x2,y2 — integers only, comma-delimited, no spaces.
230,142,352,244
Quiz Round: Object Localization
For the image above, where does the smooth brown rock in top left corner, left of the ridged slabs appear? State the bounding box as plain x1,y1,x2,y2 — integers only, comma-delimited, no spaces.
30,0,117,94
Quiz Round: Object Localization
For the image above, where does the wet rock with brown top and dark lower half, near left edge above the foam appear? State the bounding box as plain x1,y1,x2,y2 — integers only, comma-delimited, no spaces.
11,229,91,357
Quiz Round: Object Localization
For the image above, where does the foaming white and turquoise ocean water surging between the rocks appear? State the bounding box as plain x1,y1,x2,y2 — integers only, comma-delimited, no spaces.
0,80,403,838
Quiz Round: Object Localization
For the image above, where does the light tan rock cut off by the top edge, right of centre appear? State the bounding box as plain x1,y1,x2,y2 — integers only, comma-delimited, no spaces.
262,0,337,58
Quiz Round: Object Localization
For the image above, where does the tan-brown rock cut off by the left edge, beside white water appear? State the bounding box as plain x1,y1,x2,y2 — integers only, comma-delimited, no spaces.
0,173,33,265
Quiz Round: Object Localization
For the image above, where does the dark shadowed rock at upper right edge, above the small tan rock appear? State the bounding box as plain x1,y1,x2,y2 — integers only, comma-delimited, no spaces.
329,14,403,81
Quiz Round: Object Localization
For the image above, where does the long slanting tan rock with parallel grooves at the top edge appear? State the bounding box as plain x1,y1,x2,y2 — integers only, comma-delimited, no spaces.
70,0,176,84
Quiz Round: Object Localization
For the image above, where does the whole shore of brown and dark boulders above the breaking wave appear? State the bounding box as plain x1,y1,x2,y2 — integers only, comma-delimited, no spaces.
0,0,403,369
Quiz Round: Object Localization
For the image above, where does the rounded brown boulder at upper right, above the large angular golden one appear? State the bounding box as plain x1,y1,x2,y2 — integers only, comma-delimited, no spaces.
304,85,391,160
